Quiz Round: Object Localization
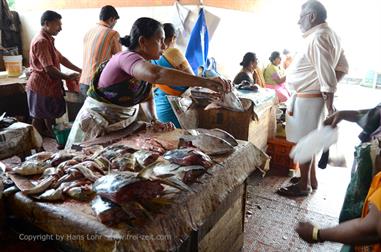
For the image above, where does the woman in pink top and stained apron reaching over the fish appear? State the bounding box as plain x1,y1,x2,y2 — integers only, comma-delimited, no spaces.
66,18,231,148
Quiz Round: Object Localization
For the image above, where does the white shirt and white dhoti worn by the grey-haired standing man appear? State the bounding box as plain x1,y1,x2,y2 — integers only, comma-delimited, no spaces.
286,23,348,143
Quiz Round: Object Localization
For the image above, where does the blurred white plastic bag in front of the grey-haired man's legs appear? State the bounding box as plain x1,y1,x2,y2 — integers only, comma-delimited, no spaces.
290,126,339,164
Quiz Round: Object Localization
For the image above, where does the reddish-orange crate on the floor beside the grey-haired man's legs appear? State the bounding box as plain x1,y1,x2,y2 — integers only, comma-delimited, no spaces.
266,137,298,176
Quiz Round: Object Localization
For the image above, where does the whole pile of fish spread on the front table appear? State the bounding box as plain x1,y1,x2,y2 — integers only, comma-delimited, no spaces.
8,129,238,225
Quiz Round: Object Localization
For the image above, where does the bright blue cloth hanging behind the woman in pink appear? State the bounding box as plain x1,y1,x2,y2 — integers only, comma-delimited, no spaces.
185,8,209,74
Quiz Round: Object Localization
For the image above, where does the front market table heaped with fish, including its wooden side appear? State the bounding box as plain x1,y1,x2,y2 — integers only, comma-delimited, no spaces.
6,125,268,251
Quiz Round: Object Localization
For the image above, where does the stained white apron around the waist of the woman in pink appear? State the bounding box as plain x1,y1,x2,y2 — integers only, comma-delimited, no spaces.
65,97,139,149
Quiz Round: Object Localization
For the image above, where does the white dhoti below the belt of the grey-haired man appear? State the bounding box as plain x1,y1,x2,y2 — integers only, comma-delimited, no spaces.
286,97,324,143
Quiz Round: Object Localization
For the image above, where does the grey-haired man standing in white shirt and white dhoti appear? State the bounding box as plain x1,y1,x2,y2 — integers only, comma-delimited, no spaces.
277,0,348,197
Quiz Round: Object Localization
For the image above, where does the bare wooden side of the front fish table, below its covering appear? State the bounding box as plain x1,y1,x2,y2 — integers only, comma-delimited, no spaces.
178,182,246,252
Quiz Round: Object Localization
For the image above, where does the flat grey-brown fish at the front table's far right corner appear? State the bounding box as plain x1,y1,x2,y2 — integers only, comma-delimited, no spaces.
179,133,234,155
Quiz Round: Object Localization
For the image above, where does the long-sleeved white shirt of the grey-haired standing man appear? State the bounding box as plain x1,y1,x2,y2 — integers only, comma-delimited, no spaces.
286,23,348,93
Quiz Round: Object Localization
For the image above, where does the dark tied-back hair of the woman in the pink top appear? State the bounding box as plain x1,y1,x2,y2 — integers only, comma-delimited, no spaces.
120,17,163,50
